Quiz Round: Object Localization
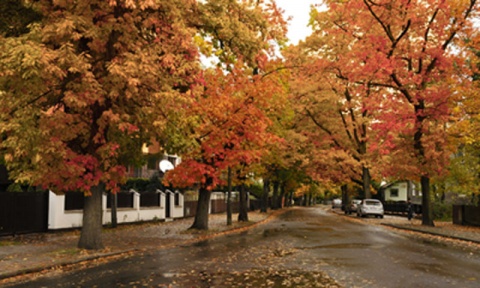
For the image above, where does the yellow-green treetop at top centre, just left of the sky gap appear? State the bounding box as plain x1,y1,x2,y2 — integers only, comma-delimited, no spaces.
192,0,286,72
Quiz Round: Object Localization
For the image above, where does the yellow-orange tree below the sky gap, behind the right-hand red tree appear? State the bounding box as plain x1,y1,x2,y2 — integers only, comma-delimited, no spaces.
285,41,376,201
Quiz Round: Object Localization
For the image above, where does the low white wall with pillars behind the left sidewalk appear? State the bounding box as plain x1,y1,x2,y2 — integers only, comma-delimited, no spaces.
48,189,184,230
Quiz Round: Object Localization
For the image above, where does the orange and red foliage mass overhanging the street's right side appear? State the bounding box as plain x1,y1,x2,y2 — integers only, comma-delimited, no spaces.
292,0,478,187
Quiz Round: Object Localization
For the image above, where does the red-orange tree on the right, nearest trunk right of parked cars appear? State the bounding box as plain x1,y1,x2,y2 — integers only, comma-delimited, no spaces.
312,0,478,225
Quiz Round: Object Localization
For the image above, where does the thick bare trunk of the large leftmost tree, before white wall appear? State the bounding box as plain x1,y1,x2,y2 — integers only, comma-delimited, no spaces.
78,184,104,250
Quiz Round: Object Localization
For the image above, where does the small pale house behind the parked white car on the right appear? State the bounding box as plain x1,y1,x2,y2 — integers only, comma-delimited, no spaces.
380,180,422,204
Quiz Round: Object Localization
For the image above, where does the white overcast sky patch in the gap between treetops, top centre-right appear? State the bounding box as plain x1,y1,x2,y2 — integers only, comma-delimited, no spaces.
276,0,322,44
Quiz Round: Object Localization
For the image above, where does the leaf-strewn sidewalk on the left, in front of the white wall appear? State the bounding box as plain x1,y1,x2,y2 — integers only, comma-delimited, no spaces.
0,210,283,286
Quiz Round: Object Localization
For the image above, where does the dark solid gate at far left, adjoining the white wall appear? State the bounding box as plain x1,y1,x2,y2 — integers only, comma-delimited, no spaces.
0,192,48,236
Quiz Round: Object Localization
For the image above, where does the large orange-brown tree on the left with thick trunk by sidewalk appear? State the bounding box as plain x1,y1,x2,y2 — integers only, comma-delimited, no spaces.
0,0,199,249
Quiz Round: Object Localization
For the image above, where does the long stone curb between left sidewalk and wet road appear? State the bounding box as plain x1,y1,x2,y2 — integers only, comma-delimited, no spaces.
0,209,289,281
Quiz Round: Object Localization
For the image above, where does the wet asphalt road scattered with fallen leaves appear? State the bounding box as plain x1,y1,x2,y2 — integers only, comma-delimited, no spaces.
6,208,480,287
